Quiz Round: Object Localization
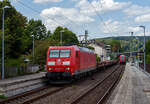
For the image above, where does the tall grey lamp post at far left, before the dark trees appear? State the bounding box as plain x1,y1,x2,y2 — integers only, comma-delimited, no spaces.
2,6,10,80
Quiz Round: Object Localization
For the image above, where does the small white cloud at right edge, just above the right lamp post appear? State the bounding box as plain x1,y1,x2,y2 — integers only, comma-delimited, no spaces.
135,13,150,22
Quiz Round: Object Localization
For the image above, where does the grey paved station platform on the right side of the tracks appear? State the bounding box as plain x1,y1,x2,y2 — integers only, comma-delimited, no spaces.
106,63,150,104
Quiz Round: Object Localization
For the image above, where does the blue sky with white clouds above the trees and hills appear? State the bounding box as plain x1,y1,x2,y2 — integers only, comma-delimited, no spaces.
10,0,150,39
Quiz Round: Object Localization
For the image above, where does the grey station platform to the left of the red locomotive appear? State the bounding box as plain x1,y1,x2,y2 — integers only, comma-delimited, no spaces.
0,72,46,97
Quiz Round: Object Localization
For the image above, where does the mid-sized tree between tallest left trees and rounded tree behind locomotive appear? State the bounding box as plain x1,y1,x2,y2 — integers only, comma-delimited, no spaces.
22,19,51,52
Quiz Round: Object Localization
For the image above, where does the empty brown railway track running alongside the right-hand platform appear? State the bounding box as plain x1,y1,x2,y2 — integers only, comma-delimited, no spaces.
71,65,125,104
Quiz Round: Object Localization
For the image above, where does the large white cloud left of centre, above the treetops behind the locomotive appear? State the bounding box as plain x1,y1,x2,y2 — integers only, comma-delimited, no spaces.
40,7,94,29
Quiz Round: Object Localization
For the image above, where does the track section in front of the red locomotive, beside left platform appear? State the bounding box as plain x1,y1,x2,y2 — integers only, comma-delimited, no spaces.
0,85,67,104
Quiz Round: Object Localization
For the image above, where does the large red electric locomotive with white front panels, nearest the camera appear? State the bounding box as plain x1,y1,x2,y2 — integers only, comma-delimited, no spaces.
46,45,96,83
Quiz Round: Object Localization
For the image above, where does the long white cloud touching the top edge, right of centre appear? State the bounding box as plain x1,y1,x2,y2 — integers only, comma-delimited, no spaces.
76,0,130,15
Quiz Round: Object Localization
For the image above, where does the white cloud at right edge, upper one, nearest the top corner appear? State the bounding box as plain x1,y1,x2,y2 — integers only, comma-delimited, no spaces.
123,5,150,16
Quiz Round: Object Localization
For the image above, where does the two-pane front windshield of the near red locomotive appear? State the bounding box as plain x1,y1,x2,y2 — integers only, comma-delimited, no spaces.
49,49,70,58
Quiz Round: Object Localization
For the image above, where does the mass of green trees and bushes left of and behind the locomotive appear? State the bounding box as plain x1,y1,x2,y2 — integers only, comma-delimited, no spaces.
0,0,79,75
